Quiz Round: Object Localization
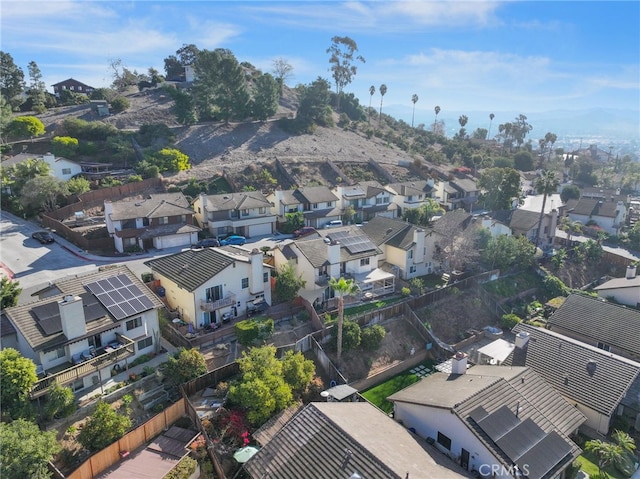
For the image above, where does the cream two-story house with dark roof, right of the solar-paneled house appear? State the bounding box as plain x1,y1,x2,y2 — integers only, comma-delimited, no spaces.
145,246,271,329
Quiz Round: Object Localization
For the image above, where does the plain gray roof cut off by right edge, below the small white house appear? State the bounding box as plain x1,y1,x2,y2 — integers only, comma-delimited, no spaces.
549,294,640,356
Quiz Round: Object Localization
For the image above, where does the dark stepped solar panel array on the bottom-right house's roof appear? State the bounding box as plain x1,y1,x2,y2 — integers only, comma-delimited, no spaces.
470,406,572,479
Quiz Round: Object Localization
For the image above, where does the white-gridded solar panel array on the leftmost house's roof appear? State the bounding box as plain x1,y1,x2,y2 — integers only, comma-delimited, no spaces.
86,274,153,321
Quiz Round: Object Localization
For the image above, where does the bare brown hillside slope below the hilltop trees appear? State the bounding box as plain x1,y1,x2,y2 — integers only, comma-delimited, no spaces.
33,89,424,190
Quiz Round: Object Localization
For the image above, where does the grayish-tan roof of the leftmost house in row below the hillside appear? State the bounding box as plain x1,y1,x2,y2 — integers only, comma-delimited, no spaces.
110,193,193,221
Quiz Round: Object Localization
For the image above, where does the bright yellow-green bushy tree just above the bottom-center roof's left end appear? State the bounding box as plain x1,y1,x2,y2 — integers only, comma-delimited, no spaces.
229,346,293,426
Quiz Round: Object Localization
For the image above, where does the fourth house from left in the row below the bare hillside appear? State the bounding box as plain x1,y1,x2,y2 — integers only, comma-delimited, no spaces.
334,181,398,222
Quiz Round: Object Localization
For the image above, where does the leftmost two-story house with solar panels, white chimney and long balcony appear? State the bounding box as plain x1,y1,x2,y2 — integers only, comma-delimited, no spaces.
3,266,163,398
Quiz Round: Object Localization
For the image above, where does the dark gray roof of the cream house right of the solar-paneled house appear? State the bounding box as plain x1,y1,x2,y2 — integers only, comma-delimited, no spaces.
144,248,233,291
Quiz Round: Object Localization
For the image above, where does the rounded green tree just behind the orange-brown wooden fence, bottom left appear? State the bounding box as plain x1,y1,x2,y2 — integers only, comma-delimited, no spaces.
77,400,131,452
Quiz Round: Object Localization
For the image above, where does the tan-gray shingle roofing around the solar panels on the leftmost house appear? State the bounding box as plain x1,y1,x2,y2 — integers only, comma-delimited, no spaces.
5,266,163,351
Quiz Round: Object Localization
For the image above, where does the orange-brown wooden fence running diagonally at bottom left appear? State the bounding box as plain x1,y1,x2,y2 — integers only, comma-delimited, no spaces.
67,398,187,479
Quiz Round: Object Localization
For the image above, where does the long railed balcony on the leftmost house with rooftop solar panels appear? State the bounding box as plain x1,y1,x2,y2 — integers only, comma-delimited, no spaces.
31,333,136,399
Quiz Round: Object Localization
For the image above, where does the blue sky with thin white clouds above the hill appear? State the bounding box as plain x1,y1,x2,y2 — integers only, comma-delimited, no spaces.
0,0,640,130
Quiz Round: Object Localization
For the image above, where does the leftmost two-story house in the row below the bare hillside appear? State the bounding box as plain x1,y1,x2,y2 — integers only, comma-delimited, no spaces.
104,193,200,253
